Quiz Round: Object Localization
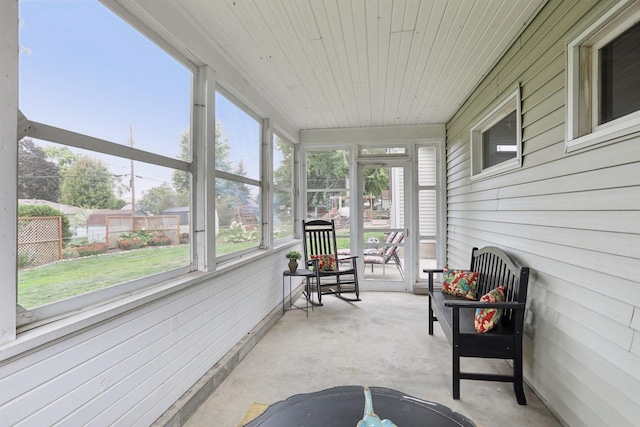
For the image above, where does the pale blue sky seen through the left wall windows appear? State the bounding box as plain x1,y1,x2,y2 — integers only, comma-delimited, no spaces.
19,0,260,200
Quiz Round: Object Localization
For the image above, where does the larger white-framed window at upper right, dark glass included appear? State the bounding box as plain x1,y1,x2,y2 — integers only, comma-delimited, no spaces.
566,0,640,151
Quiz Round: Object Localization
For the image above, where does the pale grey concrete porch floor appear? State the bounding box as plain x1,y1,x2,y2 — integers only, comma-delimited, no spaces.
185,292,561,427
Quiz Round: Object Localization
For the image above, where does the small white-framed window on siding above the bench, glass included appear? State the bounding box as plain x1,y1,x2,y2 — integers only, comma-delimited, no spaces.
471,86,522,179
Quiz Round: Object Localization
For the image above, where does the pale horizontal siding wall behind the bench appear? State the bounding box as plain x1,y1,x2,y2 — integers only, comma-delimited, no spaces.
447,0,640,427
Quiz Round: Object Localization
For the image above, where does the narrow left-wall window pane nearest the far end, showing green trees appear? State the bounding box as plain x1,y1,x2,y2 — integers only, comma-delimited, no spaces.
272,133,294,240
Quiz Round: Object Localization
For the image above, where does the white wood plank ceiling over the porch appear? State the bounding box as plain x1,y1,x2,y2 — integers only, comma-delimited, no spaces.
149,0,544,129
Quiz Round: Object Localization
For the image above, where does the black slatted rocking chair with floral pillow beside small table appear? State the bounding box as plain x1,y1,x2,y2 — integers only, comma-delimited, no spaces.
302,220,360,305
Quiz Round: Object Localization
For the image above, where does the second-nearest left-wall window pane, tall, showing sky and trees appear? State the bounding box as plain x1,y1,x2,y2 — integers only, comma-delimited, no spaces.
215,91,262,259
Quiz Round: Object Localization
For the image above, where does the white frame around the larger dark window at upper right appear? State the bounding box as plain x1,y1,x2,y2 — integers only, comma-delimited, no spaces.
565,0,640,152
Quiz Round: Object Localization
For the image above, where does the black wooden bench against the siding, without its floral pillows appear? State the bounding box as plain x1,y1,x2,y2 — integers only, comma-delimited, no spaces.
424,247,529,405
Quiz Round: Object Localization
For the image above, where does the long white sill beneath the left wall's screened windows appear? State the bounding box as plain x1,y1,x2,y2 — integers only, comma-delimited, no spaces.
0,240,301,363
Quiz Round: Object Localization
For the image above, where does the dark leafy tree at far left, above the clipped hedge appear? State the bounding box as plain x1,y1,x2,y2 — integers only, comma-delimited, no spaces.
18,138,60,202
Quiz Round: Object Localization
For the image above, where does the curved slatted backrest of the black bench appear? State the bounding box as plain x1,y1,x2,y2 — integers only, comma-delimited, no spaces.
471,246,529,323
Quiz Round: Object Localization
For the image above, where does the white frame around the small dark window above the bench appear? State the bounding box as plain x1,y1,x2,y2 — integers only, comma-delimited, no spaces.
471,84,522,181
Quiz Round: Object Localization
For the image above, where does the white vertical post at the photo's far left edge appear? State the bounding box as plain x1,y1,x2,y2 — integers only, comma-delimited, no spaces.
0,1,18,345
